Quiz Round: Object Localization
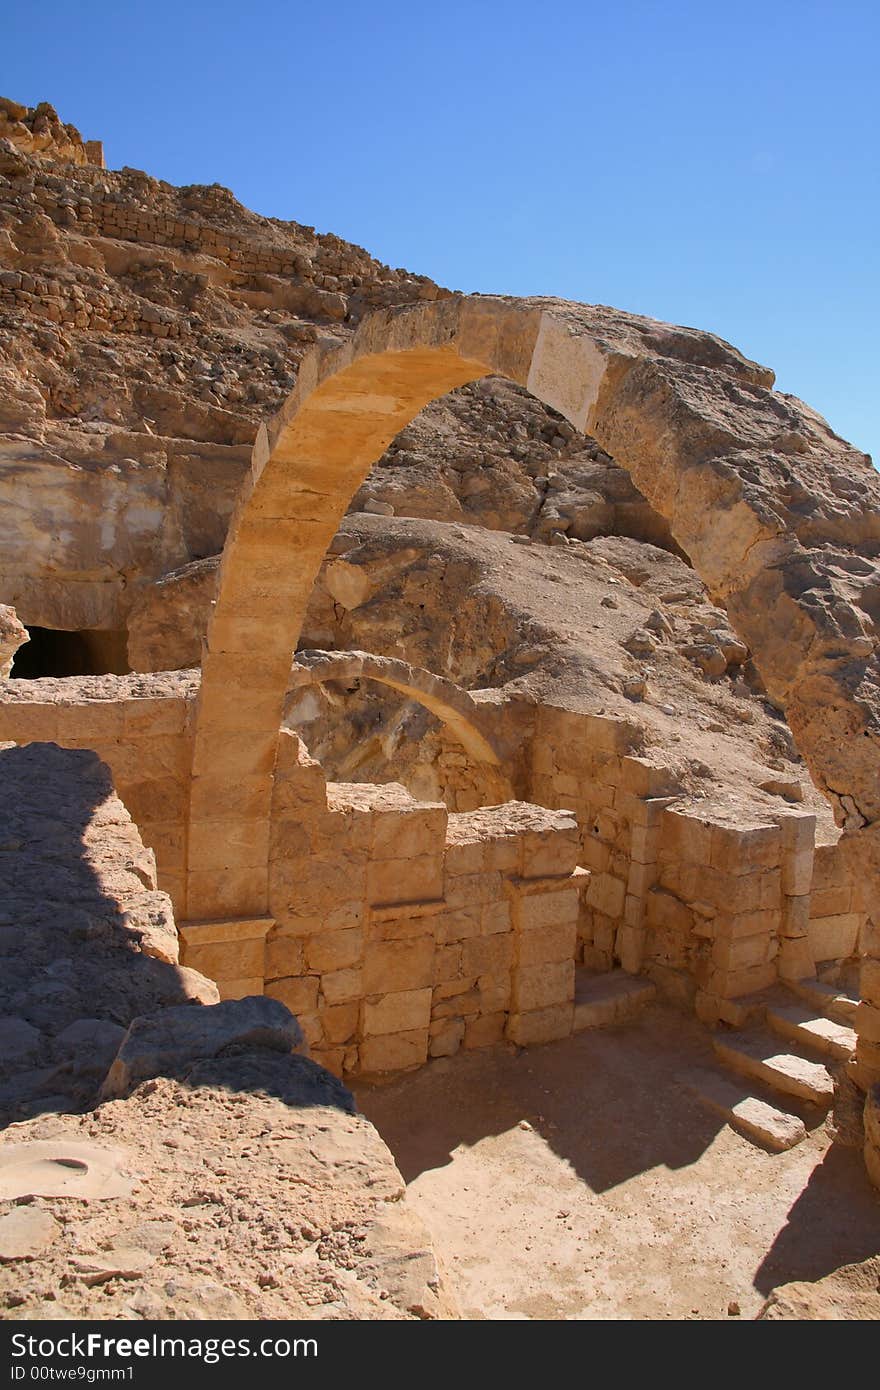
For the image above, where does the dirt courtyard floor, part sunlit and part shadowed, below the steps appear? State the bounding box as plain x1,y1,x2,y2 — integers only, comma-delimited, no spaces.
357,1006,880,1319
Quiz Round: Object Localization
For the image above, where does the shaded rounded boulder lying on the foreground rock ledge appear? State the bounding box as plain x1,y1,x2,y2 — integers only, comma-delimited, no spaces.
100,995,303,1101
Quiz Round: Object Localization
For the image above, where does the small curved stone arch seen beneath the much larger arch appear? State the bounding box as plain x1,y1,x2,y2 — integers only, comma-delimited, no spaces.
291,652,500,767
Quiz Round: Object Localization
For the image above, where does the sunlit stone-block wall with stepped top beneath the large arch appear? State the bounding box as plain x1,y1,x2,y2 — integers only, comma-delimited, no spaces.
181,733,588,1074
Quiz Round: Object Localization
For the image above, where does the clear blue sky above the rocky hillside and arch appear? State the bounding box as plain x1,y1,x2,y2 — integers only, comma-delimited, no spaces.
0,0,880,461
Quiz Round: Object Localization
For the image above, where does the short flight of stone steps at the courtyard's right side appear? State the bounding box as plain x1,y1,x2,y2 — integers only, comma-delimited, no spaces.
683,980,858,1150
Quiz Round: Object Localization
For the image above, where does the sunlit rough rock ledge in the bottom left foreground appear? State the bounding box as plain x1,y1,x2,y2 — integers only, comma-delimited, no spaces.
0,1056,457,1321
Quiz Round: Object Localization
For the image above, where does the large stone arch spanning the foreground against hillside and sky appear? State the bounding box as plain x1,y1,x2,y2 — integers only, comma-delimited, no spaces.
186,296,880,920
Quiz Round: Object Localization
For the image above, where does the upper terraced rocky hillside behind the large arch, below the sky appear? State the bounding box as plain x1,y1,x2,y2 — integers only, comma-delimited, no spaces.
0,103,670,636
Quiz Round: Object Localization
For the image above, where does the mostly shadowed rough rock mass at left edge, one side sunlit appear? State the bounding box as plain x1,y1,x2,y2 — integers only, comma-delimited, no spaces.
0,744,218,1120
